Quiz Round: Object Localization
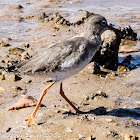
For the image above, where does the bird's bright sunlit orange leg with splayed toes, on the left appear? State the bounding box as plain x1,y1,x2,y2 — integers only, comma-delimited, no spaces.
27,82,55,126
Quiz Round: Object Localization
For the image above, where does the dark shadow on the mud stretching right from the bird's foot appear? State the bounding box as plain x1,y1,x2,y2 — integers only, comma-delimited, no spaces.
84,107,140,120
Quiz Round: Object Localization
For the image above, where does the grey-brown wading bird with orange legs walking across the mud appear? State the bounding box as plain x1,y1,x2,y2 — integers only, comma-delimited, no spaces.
17,15,108,126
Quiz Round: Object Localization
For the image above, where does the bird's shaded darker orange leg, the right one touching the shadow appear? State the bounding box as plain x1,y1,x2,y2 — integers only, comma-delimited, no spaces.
60,83,84,114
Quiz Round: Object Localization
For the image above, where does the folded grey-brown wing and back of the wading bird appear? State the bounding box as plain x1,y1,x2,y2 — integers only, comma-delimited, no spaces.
17,37,96,77
